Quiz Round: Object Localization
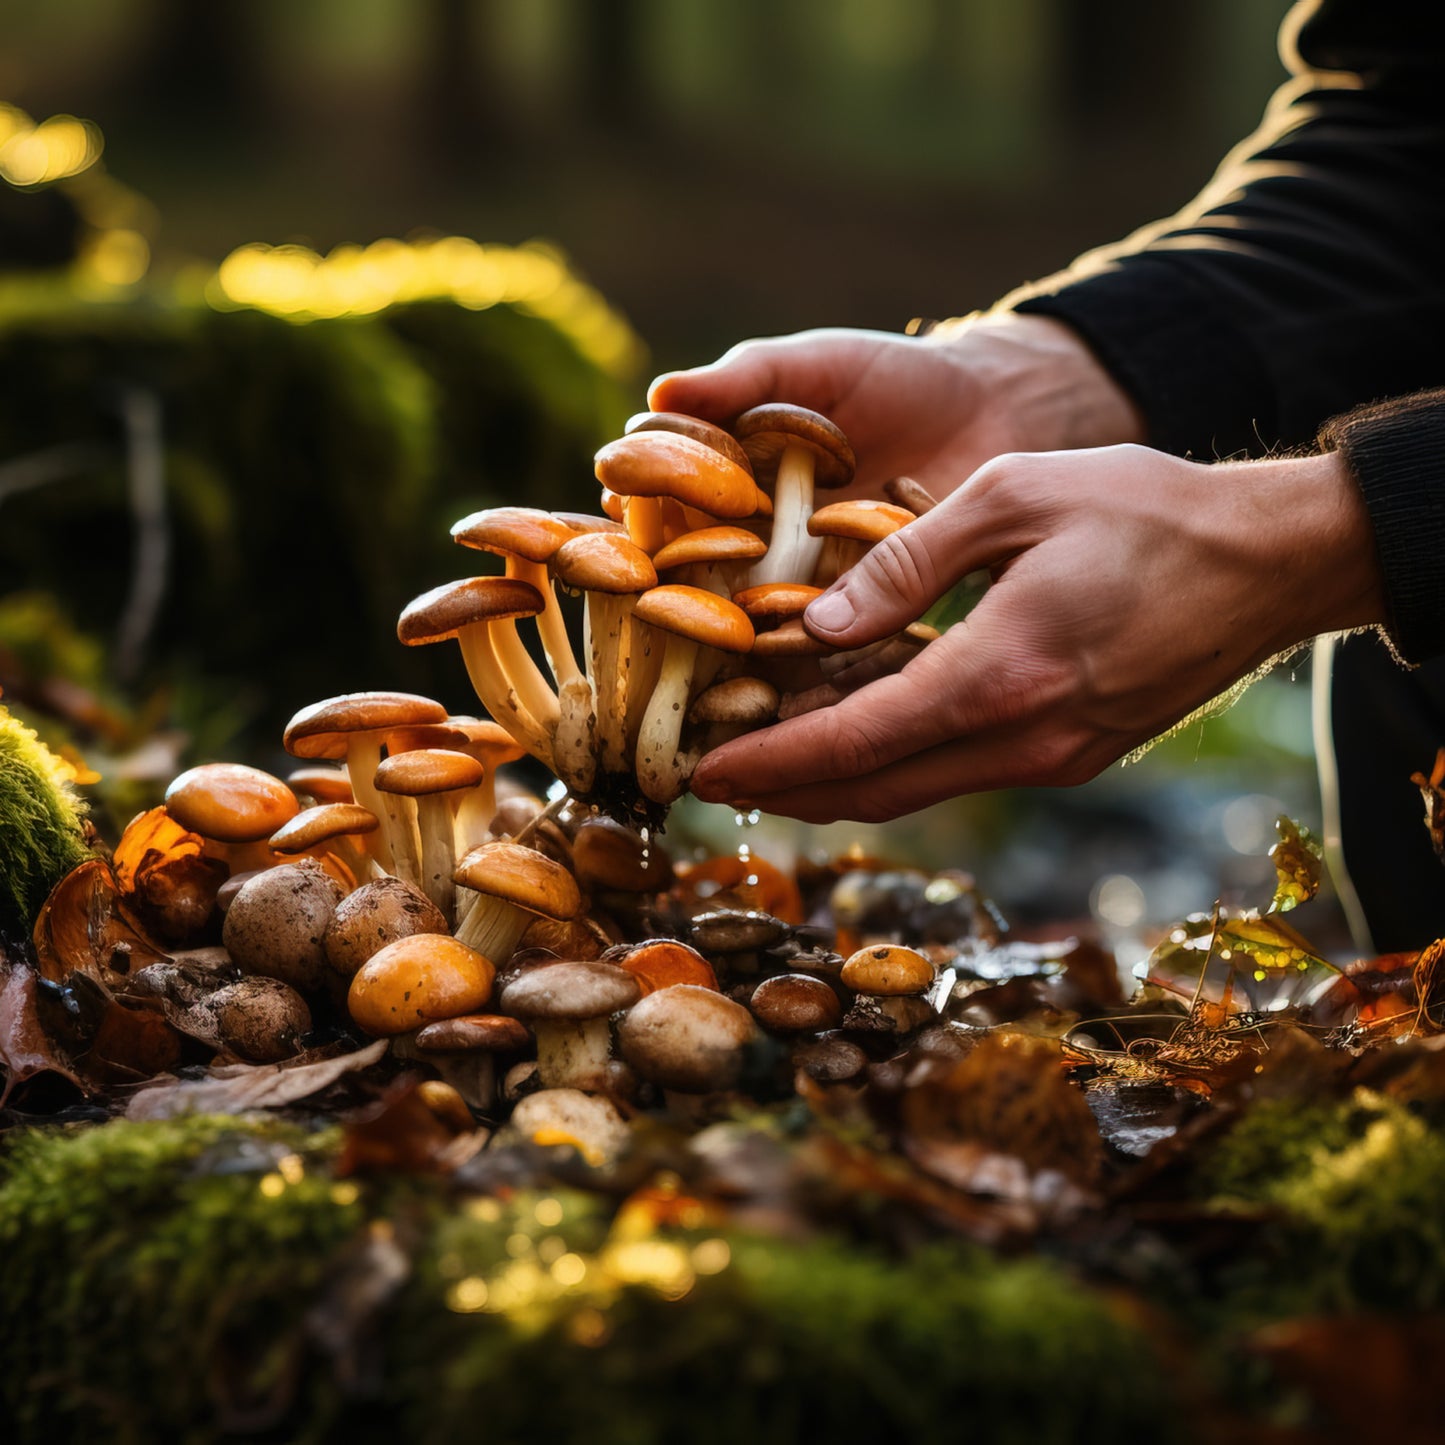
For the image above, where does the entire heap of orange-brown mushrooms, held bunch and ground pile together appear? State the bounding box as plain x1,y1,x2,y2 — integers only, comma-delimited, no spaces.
140,406,980,1159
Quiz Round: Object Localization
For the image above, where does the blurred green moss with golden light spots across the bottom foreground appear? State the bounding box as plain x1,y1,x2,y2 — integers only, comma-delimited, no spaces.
0,1118,1181,1445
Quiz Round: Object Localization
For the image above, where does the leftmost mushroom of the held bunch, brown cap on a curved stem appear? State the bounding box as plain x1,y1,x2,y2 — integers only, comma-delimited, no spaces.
395,577,559,772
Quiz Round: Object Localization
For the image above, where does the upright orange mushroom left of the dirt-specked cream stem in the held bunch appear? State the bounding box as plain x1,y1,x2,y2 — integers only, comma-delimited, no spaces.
552,532,660,773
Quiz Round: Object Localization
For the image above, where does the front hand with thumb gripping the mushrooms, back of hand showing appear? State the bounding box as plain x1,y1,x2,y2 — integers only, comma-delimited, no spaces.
692,445,1386,822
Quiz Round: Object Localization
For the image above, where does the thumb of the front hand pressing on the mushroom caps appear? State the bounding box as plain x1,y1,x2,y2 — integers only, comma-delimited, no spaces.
803,467,1042,649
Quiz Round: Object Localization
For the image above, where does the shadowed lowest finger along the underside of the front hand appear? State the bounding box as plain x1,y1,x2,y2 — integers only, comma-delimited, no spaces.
708,728,1098,824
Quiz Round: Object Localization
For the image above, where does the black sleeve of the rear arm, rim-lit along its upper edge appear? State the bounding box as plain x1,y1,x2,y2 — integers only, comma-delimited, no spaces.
1004,0,1445,460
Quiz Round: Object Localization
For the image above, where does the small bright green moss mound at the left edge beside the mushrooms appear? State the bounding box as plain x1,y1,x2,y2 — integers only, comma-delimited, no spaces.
0,707,90,939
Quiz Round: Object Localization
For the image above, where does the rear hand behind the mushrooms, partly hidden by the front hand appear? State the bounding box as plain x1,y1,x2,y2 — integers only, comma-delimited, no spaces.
647,312,1143,499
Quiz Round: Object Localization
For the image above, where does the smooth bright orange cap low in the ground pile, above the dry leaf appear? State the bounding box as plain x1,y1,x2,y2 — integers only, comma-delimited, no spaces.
347,933,496,1038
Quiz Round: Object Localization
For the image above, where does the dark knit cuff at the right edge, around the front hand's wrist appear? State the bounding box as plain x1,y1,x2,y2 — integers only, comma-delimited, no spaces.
1319,390,1445,662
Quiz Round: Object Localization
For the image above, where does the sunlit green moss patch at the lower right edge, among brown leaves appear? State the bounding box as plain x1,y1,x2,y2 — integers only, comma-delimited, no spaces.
1205,1090,1445,1318
